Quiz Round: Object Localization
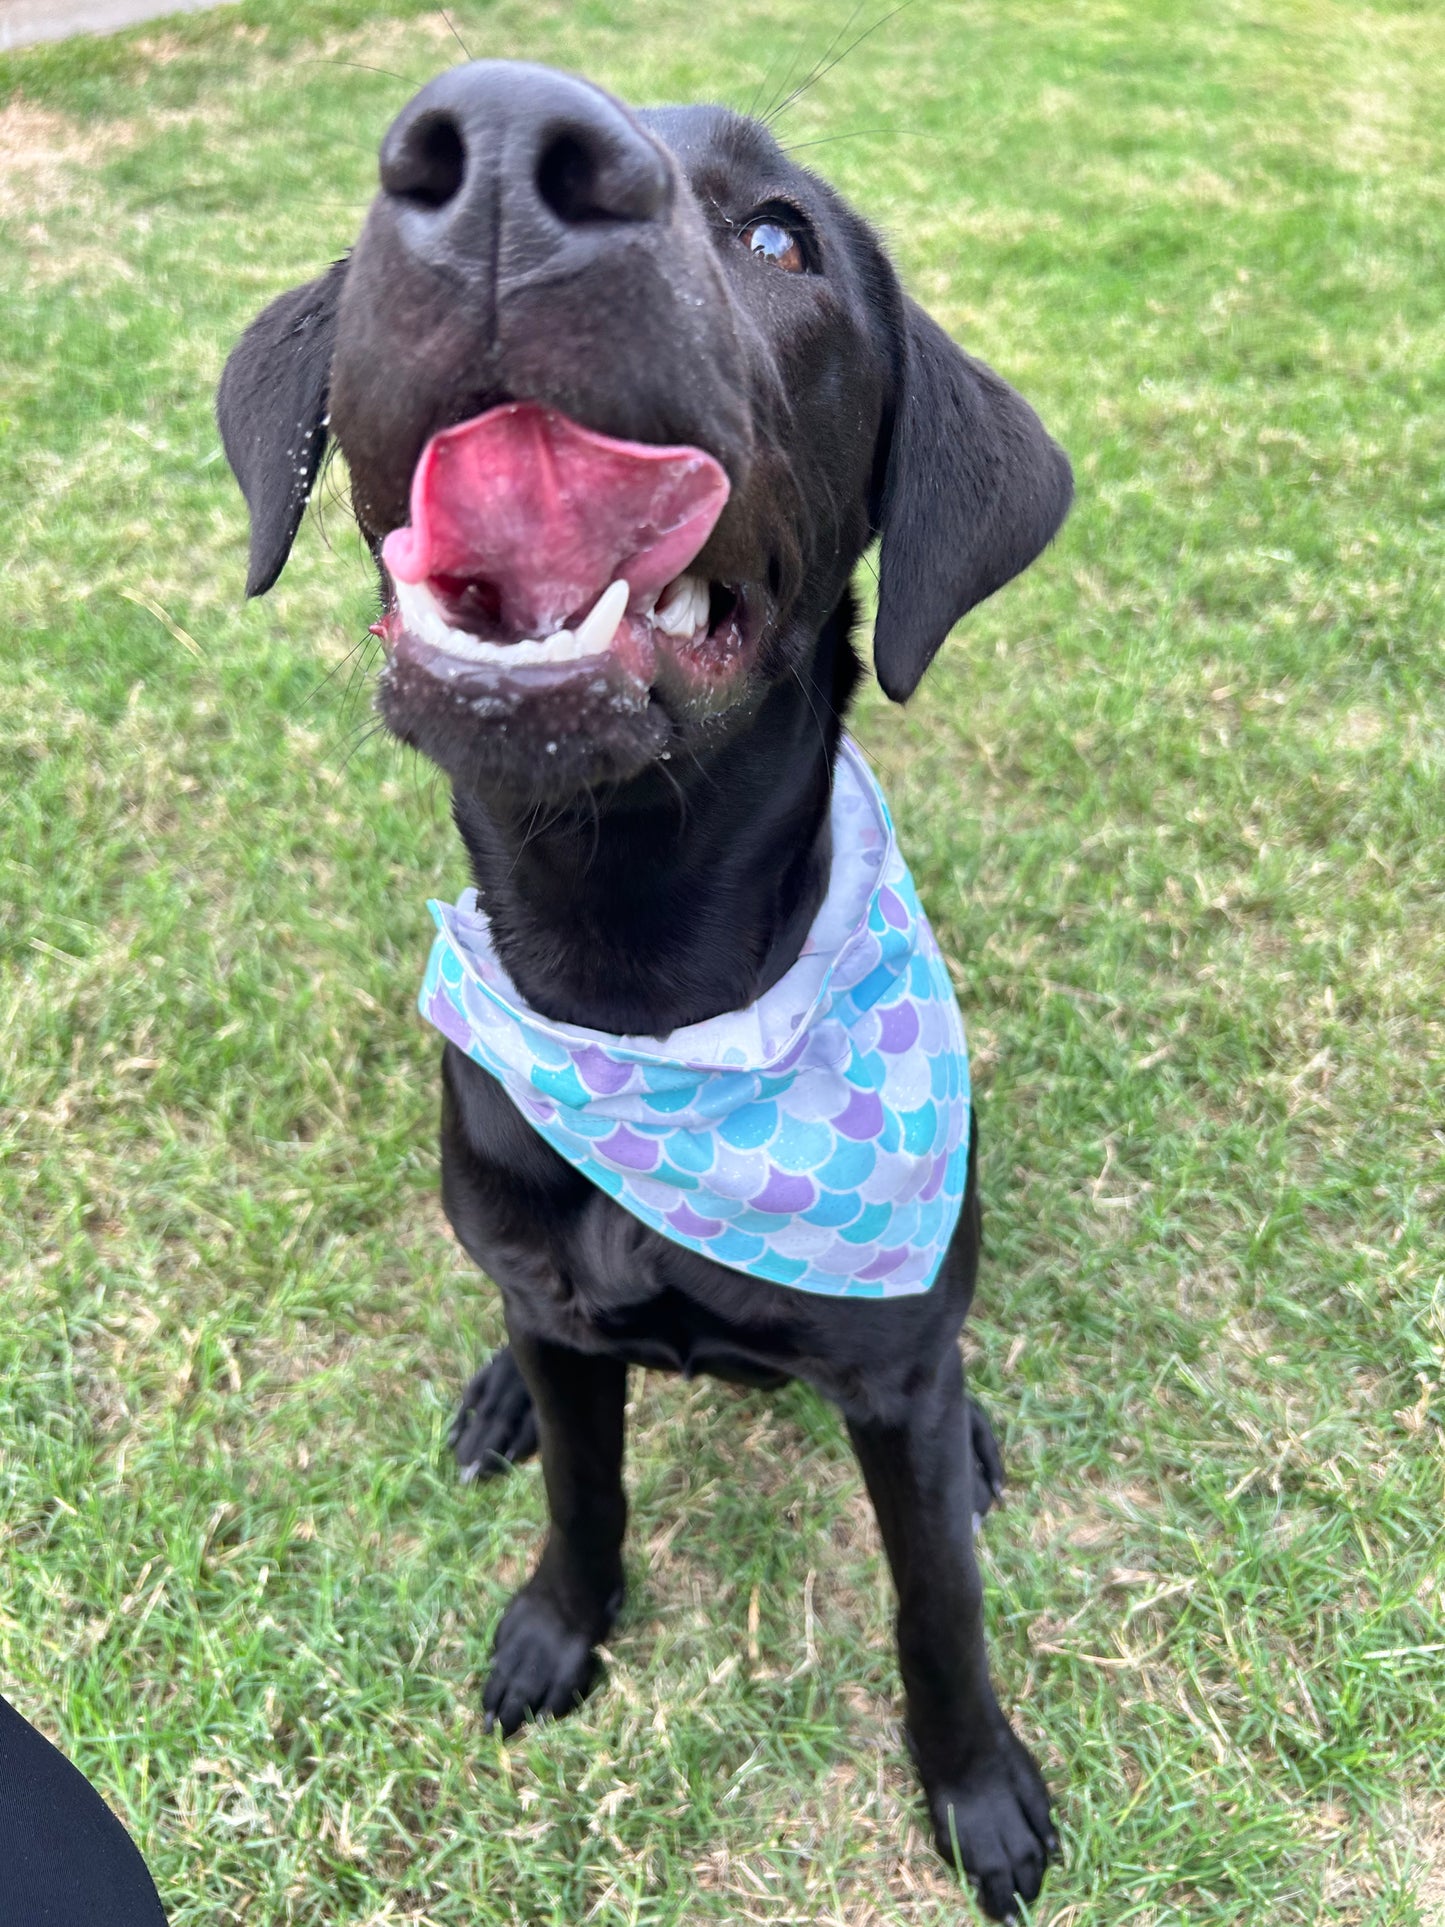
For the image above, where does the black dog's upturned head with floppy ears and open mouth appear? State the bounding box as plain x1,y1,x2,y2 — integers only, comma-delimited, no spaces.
218,62,1071,796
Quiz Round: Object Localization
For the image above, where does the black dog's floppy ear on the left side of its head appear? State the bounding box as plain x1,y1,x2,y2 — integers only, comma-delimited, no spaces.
216,260,347,595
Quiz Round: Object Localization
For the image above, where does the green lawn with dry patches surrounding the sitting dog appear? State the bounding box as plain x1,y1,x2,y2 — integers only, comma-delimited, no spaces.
0,0,1445,1927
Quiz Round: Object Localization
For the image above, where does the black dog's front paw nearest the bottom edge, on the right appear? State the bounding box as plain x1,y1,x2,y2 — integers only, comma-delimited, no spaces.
925,1725,1058,1919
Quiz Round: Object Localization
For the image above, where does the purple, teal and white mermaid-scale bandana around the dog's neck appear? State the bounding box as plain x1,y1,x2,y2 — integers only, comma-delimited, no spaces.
420,738,969,1299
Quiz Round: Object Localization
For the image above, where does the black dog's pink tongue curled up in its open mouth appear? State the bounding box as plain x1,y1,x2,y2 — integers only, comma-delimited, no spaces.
381,401,728,636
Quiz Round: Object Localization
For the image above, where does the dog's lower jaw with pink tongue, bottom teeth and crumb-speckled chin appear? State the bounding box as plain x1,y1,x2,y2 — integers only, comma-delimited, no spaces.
376,403,761,790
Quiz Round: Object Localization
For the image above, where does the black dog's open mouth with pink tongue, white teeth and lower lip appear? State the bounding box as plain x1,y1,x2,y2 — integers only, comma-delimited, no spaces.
380,403,755,717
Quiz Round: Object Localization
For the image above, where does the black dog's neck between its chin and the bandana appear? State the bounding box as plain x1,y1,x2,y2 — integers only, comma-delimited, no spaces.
453,601,857,1035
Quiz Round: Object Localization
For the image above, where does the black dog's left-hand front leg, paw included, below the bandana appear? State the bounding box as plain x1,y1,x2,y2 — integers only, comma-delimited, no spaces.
482,1330,626,1734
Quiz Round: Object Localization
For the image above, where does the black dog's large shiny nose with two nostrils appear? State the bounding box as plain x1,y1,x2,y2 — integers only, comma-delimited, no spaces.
381,60,672,254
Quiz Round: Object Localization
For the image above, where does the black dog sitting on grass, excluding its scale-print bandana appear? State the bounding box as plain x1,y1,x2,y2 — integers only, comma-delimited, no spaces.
220,62,1071,1915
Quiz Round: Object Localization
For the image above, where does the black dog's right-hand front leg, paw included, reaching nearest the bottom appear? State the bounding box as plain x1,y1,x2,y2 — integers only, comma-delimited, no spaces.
848,1345,1056,1917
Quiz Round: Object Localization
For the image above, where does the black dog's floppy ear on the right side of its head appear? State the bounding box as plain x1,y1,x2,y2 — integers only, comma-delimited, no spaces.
873,301,1073,703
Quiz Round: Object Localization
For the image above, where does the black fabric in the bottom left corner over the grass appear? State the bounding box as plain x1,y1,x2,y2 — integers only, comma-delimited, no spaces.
0,1700,166,1927
